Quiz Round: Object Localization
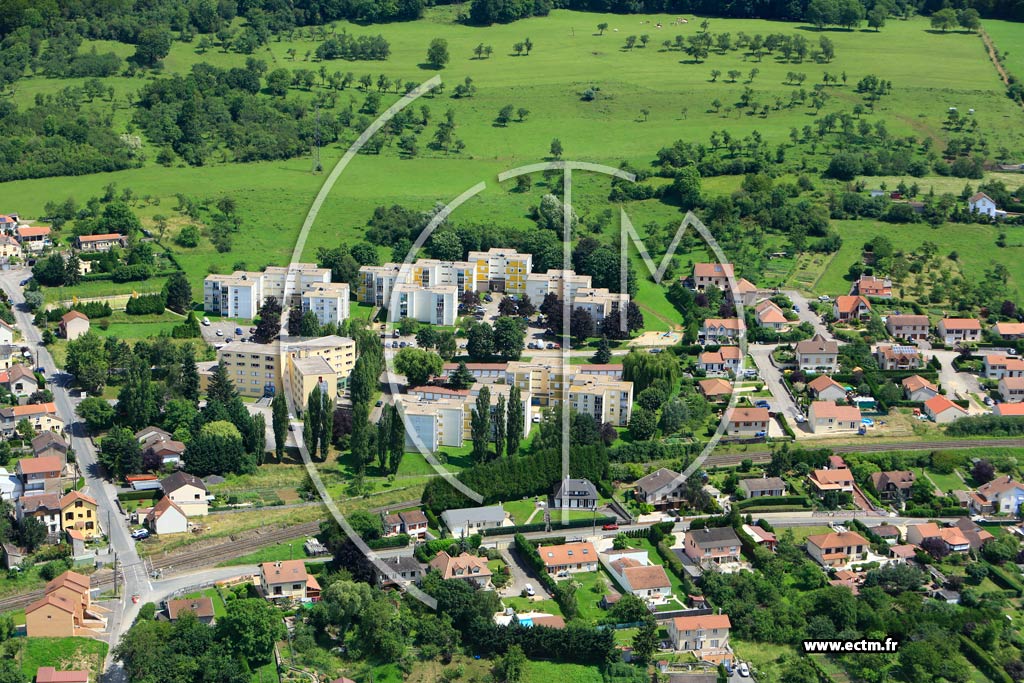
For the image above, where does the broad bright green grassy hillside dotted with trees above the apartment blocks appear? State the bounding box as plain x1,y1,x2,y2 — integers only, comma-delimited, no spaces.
2,10,1024,307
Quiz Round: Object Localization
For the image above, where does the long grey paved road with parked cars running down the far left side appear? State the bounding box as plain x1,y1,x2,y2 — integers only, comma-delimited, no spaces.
0,269,150,671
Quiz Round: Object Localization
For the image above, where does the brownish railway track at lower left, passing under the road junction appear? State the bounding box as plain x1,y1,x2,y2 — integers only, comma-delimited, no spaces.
0,501,420,612
